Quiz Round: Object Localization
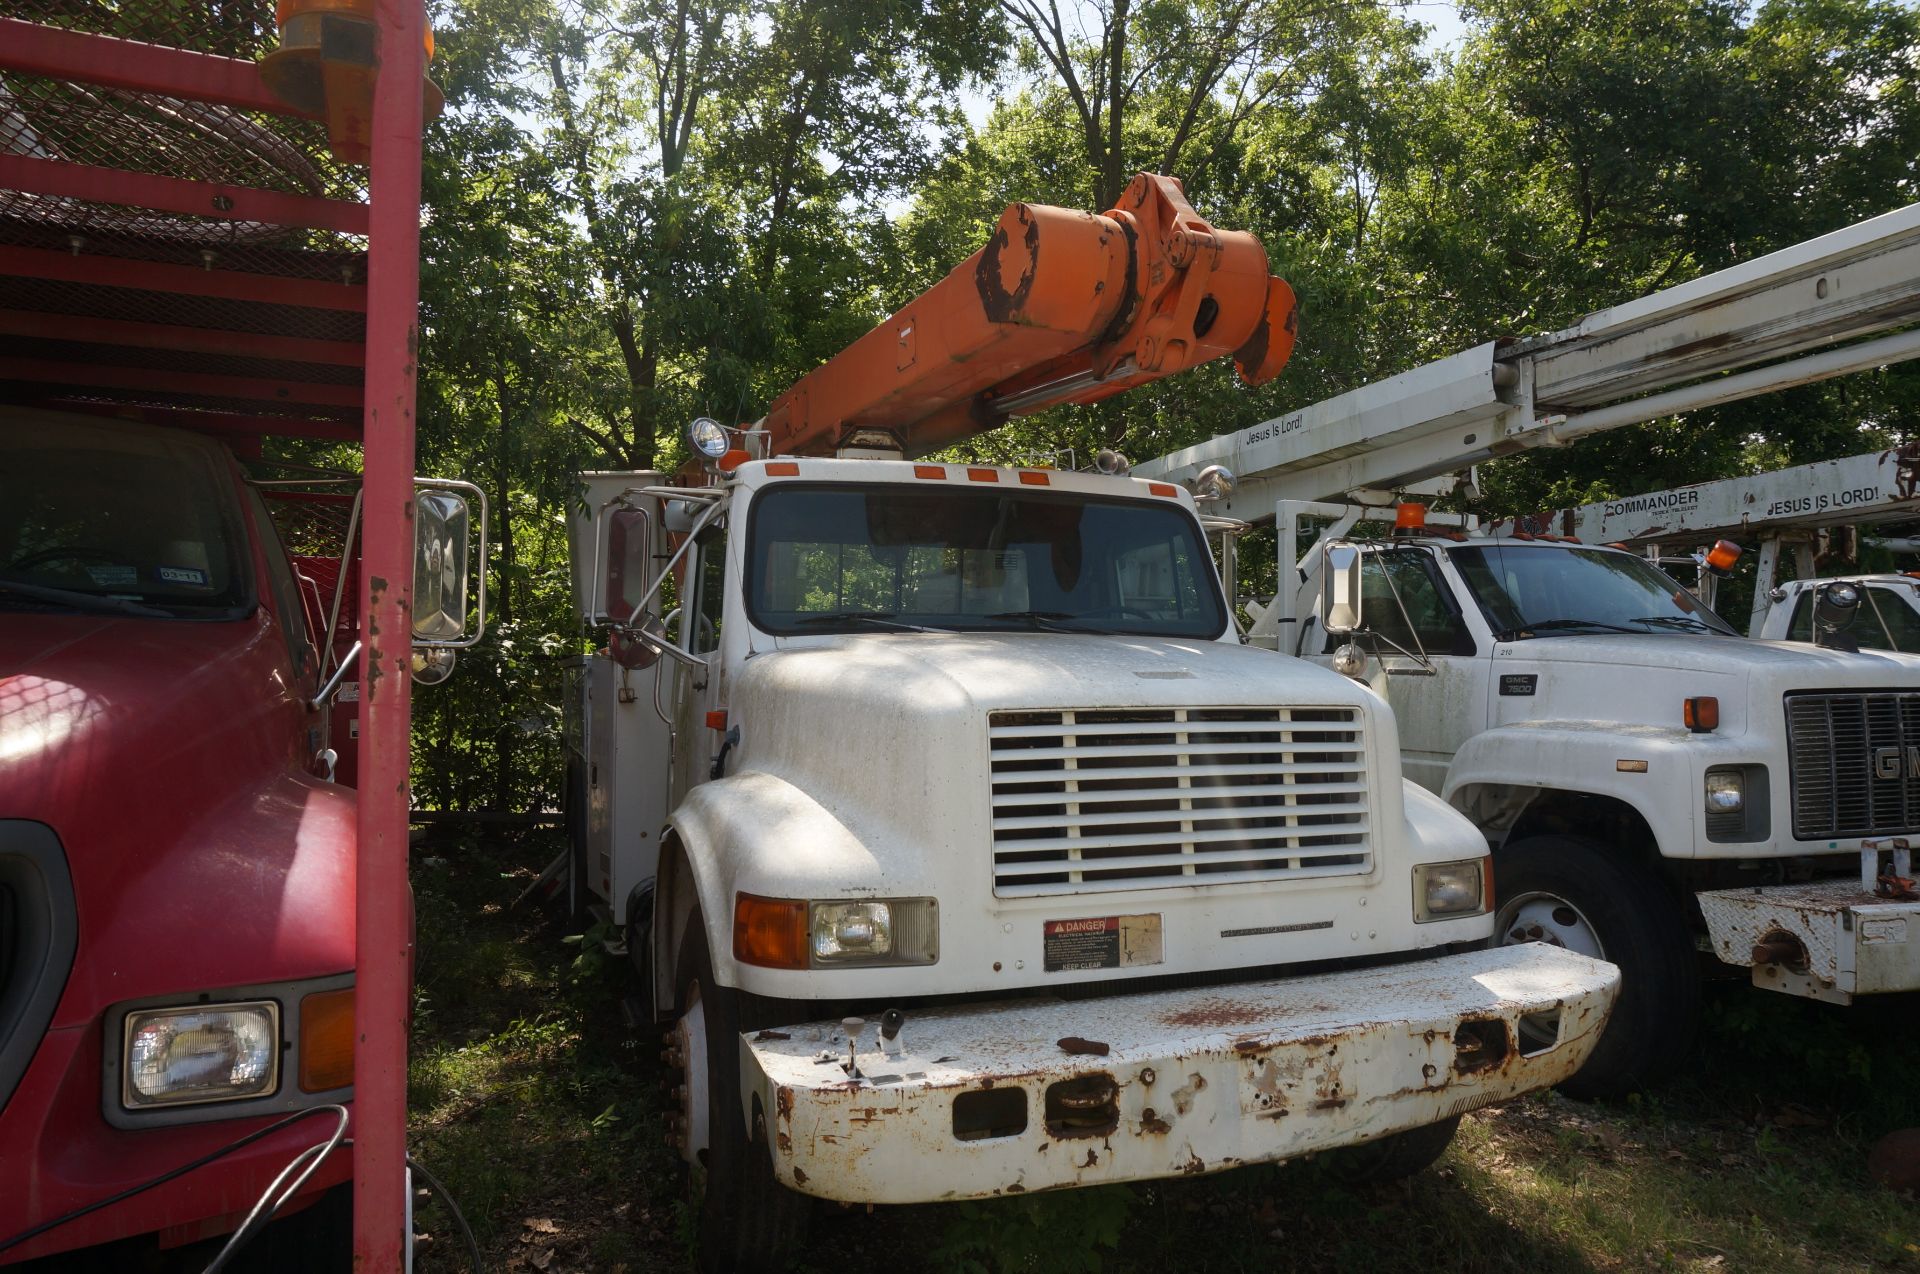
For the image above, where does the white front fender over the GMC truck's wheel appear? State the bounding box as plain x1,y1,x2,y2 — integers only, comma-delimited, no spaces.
1442,721,1707,858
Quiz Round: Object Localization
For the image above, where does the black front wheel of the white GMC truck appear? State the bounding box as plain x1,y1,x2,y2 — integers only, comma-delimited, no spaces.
1494,837,1699,1101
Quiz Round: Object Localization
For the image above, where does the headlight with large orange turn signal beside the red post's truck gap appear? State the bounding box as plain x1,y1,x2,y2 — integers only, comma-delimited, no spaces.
733,894,941,969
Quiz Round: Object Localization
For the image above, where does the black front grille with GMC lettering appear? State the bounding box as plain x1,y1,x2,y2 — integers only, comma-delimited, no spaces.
1788,691,1920,840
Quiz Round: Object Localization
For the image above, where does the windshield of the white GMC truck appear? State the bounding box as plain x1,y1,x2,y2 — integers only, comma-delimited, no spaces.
1452,543,1734,641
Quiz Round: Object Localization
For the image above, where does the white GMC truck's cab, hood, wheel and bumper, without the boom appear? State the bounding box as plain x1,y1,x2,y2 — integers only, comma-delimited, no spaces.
1282,518,1920,1096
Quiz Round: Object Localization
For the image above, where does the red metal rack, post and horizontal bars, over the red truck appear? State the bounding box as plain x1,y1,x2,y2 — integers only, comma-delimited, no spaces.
0,0,426,1272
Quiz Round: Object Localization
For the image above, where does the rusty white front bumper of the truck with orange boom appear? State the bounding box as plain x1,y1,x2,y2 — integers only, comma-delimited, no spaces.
741,944,1619,1203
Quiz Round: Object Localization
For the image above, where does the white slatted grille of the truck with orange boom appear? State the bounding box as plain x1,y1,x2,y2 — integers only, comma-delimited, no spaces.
987,708,1373,898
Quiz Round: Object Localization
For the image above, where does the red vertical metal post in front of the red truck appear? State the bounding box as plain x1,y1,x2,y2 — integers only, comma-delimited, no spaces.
353,0,426,1274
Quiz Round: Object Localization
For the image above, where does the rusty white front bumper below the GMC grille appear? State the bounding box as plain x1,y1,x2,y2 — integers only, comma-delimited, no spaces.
1697,844,1920,1003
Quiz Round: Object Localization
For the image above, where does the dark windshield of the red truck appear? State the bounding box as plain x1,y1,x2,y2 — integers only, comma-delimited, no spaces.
0,416,250,620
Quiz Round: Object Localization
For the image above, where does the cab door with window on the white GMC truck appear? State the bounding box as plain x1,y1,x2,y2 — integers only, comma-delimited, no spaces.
1306,545,1492,794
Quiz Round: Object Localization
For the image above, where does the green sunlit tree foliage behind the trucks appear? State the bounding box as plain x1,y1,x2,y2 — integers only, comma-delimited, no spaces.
397,0,1920,808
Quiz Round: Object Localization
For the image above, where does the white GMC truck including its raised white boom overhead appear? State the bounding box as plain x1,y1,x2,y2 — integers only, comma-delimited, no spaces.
1135,196,1920,1096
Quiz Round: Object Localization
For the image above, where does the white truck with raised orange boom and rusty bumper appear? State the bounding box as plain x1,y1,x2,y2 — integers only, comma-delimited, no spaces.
570,178,1617,1270
